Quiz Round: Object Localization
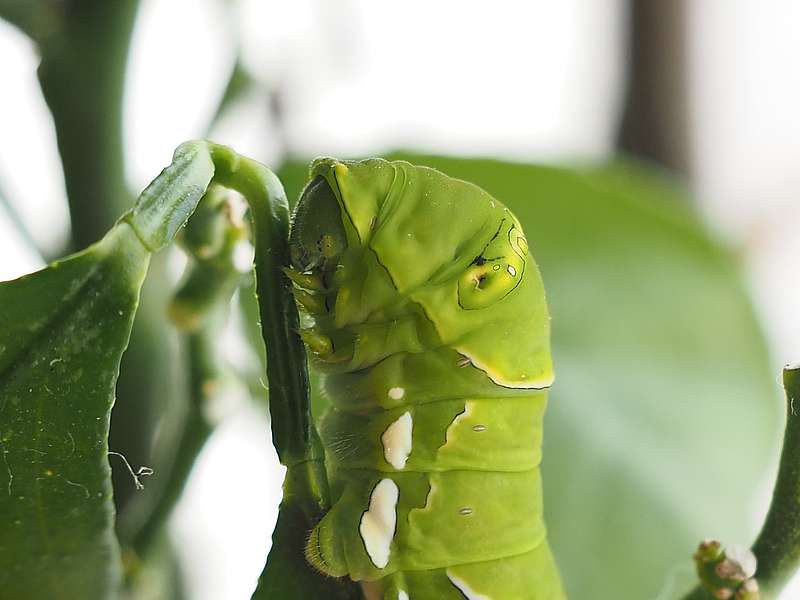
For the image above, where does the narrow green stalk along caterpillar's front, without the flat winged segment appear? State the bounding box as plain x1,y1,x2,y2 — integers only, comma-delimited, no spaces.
203,144,362,600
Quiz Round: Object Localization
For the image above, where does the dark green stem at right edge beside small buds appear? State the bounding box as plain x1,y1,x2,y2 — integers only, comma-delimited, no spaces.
683,366,800,600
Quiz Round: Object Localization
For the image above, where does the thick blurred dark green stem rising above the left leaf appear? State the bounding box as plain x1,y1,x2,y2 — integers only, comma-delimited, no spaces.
37,0,139,248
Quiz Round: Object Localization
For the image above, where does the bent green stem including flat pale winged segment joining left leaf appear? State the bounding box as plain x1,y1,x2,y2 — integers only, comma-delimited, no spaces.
122,141,344,600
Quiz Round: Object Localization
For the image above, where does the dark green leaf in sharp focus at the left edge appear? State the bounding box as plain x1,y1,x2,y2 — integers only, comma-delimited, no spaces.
0,224,150,600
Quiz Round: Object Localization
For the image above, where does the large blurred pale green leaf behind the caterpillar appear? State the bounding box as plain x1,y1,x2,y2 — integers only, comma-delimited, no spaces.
281,155,781,600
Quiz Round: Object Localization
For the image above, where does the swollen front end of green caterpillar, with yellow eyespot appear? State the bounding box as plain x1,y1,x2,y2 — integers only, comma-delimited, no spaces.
290,158,552,387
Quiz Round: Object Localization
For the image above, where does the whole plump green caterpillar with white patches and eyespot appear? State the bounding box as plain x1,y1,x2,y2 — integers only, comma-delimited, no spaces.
290,159,564,600
